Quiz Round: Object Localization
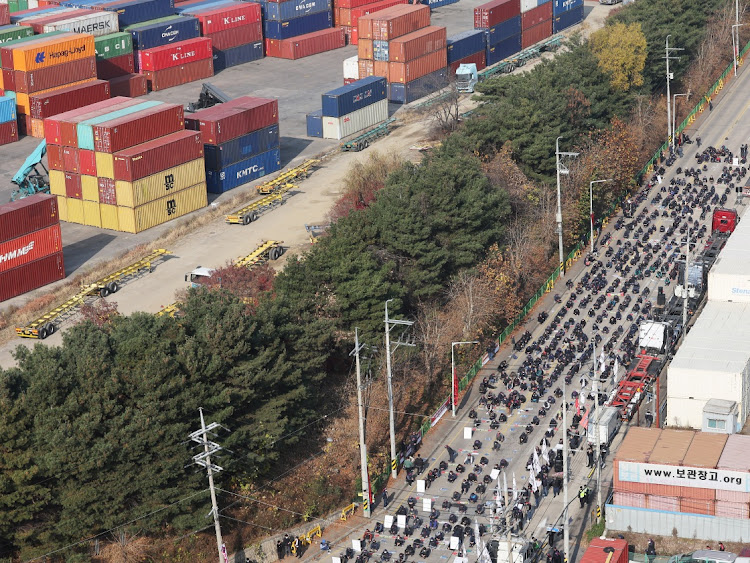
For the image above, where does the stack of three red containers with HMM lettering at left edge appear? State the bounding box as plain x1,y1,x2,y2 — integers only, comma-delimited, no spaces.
0,194,65,301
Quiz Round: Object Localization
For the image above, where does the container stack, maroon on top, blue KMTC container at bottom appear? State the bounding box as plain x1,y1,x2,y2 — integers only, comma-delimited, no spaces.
185,96,281,193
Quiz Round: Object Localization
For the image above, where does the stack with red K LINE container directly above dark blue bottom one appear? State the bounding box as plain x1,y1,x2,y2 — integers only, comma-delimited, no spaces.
176,2,263,72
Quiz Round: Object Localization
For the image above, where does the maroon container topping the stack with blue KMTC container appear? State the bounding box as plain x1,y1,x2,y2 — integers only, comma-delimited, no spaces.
185,96,279,145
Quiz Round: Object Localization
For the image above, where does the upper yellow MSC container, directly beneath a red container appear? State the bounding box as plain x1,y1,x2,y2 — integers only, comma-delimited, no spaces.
114,158,206,209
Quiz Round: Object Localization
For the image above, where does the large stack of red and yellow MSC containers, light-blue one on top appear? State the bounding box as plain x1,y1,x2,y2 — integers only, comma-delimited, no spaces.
45,97,207,233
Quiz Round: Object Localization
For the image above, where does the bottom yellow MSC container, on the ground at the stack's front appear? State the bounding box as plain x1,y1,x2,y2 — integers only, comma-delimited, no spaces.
117,182,208,233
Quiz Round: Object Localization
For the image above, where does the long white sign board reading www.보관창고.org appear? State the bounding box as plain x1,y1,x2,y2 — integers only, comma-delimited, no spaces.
618,461,750,493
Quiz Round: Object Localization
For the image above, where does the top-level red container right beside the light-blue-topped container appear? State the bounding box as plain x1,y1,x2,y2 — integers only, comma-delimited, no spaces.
92,104,185,153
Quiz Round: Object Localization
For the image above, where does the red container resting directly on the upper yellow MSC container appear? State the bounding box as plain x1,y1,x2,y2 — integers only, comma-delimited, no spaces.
114,131,203,182
